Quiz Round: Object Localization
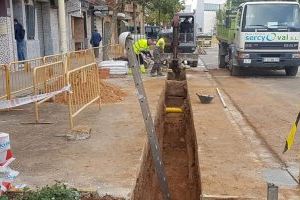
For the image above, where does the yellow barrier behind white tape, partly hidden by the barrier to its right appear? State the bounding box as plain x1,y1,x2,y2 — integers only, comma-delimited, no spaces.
6,57,44,99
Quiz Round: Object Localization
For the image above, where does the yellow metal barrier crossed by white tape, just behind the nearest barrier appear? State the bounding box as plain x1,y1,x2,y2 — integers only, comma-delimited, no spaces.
33,61,66,122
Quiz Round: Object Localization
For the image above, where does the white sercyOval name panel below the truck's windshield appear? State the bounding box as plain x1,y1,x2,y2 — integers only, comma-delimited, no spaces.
245,33,298,42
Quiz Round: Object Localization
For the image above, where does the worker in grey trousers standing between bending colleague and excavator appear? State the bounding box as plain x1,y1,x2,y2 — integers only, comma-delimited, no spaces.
150,38,166,77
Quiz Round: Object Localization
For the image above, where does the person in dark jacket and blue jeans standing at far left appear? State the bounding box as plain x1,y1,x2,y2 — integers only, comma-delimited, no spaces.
14,19,25,61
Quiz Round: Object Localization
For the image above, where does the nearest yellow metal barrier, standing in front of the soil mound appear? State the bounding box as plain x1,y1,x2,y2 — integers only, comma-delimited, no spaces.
67,63,100,129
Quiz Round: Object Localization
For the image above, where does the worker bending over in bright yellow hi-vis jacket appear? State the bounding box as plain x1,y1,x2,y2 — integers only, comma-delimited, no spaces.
133,39,154,72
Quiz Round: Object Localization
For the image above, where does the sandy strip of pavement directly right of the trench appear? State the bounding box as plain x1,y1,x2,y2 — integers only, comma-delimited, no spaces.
187,68,299,199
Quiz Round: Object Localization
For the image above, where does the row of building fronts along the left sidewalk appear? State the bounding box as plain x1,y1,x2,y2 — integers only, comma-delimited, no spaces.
0,0,143,64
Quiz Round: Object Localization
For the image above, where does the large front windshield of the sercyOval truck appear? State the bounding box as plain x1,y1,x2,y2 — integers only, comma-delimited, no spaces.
242,4,300,31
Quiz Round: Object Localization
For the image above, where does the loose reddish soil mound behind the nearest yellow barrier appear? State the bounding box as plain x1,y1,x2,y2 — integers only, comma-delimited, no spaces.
54,81,127,104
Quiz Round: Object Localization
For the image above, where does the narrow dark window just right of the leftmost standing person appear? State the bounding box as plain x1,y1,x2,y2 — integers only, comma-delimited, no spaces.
25,5,35,40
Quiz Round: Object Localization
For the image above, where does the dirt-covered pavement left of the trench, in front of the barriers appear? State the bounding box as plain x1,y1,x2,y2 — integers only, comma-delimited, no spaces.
0,77,163,198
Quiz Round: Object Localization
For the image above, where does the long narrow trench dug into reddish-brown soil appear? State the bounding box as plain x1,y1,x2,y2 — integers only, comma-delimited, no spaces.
132,73,201,200
